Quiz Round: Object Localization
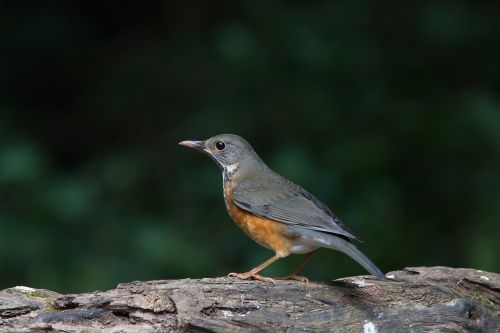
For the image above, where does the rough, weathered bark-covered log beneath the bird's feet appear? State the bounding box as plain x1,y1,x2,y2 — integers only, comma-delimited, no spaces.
0,267,500,333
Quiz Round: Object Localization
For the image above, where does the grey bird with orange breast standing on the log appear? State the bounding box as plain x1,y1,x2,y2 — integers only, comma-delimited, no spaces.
179,134,384,283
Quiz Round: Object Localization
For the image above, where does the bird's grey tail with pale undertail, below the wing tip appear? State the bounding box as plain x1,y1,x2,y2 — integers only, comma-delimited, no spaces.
292,230,384,278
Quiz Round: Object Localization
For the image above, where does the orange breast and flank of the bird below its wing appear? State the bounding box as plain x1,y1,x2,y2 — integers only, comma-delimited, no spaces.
224,184,292,257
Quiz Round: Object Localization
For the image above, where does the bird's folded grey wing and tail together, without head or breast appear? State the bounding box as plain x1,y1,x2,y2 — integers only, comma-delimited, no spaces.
233,172,384,277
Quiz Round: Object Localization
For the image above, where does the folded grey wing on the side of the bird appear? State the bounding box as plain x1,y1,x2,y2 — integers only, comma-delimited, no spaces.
233,175,358,239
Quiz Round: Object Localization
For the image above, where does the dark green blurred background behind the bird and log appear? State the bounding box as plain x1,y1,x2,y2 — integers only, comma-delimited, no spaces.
0,1,500,292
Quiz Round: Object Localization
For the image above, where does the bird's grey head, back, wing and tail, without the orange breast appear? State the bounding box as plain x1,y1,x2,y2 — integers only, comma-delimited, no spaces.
181,134,384,277
